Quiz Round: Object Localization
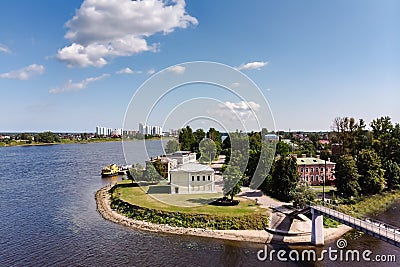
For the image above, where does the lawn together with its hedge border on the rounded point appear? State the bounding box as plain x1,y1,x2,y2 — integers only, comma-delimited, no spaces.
109,182,268,230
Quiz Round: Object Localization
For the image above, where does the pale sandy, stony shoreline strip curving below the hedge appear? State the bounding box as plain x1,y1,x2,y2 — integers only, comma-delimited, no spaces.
95,185,351,246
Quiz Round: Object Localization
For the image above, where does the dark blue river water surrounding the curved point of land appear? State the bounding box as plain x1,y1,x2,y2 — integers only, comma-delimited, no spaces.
0,141,400,266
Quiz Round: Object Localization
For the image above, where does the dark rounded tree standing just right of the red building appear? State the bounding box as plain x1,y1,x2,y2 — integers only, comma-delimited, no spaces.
335,155,361,197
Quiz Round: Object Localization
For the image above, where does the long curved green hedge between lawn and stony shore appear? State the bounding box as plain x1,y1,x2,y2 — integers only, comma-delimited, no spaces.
111,195,268,230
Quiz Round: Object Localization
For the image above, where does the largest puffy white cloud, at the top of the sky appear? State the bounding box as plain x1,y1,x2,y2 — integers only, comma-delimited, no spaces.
57,0,198,67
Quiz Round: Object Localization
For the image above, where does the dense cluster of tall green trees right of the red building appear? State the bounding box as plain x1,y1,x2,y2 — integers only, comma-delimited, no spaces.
332,117,400,197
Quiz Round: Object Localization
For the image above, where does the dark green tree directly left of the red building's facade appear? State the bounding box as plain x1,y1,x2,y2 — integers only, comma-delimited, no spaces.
270,157,299,201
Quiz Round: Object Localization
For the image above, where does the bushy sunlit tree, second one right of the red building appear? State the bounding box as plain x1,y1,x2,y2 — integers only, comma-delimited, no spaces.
357,149,385,195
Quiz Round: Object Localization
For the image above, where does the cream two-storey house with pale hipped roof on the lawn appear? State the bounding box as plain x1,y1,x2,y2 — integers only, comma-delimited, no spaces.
170,162,215,194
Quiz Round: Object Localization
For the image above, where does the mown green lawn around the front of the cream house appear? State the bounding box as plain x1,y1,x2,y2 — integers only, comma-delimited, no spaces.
114,184,265,216
